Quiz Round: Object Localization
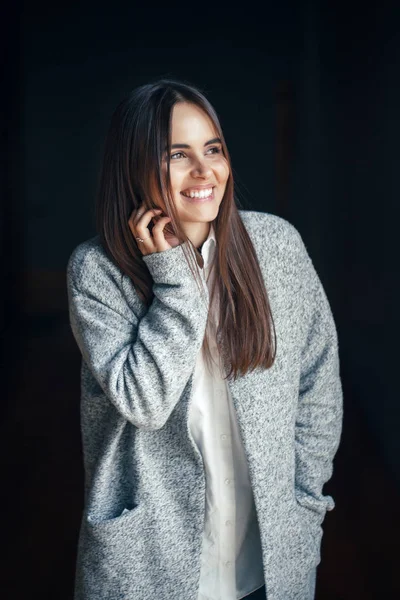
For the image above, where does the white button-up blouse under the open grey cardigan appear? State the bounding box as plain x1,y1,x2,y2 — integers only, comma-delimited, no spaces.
189,224,264,600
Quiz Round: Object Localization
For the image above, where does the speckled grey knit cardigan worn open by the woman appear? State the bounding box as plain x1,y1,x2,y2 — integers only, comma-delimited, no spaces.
67,210,343,600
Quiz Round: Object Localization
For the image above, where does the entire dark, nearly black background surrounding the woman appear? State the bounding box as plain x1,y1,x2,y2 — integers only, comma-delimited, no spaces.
0,1,400,600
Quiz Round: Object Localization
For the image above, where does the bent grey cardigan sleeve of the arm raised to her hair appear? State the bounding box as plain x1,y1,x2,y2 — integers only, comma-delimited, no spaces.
67,243,208,430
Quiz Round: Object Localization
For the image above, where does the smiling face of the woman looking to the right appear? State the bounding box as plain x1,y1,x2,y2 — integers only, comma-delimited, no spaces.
162,102,229,234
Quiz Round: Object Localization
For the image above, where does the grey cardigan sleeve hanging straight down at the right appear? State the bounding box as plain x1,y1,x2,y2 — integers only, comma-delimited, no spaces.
295,234,343,524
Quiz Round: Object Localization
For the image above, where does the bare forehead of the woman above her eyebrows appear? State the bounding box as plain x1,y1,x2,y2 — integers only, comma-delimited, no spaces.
171,102,217,144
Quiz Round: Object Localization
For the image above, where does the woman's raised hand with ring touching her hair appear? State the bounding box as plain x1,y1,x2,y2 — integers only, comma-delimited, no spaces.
128,204,181,256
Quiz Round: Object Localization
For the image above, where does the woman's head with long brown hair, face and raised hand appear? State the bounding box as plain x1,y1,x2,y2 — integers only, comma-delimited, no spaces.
96,80,276,377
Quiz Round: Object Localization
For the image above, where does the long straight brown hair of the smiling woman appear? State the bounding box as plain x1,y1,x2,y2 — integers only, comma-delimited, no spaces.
96,79,276,379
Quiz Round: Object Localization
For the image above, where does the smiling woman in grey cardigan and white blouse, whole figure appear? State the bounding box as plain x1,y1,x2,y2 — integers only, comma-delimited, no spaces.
67,80,342,600
